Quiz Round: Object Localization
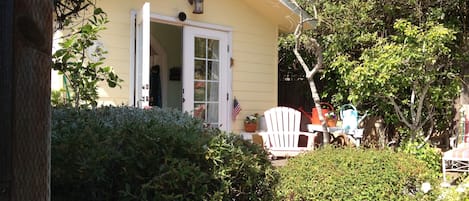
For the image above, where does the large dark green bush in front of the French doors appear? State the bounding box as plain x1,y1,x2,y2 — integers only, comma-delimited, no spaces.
51,107,276,201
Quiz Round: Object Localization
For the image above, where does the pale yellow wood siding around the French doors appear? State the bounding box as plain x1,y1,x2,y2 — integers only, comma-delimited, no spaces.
87,0,286,131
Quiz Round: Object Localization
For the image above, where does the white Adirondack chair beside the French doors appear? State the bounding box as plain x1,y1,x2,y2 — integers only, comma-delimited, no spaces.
259,107,317,158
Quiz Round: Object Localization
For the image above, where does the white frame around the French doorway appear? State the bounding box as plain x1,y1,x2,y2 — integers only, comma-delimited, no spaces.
129,6,233,131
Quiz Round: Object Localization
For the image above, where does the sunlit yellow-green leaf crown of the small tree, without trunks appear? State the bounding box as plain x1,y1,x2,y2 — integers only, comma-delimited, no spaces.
342,20,454,101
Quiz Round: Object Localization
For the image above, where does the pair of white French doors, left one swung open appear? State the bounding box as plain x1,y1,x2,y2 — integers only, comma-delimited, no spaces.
131,5,232,131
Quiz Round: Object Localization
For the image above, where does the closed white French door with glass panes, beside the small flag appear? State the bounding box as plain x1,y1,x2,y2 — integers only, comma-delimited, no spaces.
182,26,230,130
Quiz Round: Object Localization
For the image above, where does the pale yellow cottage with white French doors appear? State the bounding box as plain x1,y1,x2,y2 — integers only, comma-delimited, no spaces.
52,0,314,131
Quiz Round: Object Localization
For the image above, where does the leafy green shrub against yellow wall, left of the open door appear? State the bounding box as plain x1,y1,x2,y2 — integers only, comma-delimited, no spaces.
52,8,122,107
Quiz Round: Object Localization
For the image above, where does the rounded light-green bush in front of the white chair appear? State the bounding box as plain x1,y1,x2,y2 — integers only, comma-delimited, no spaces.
278,147,438,200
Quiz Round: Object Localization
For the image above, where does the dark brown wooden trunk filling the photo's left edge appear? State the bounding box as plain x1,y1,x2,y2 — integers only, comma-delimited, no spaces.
0,0,53,201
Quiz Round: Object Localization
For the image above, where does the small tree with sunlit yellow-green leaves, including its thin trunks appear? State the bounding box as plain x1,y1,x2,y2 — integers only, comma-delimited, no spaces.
333,20,459,139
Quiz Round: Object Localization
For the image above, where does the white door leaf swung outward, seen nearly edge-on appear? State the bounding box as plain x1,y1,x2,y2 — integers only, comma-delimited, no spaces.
134,2,150,108
